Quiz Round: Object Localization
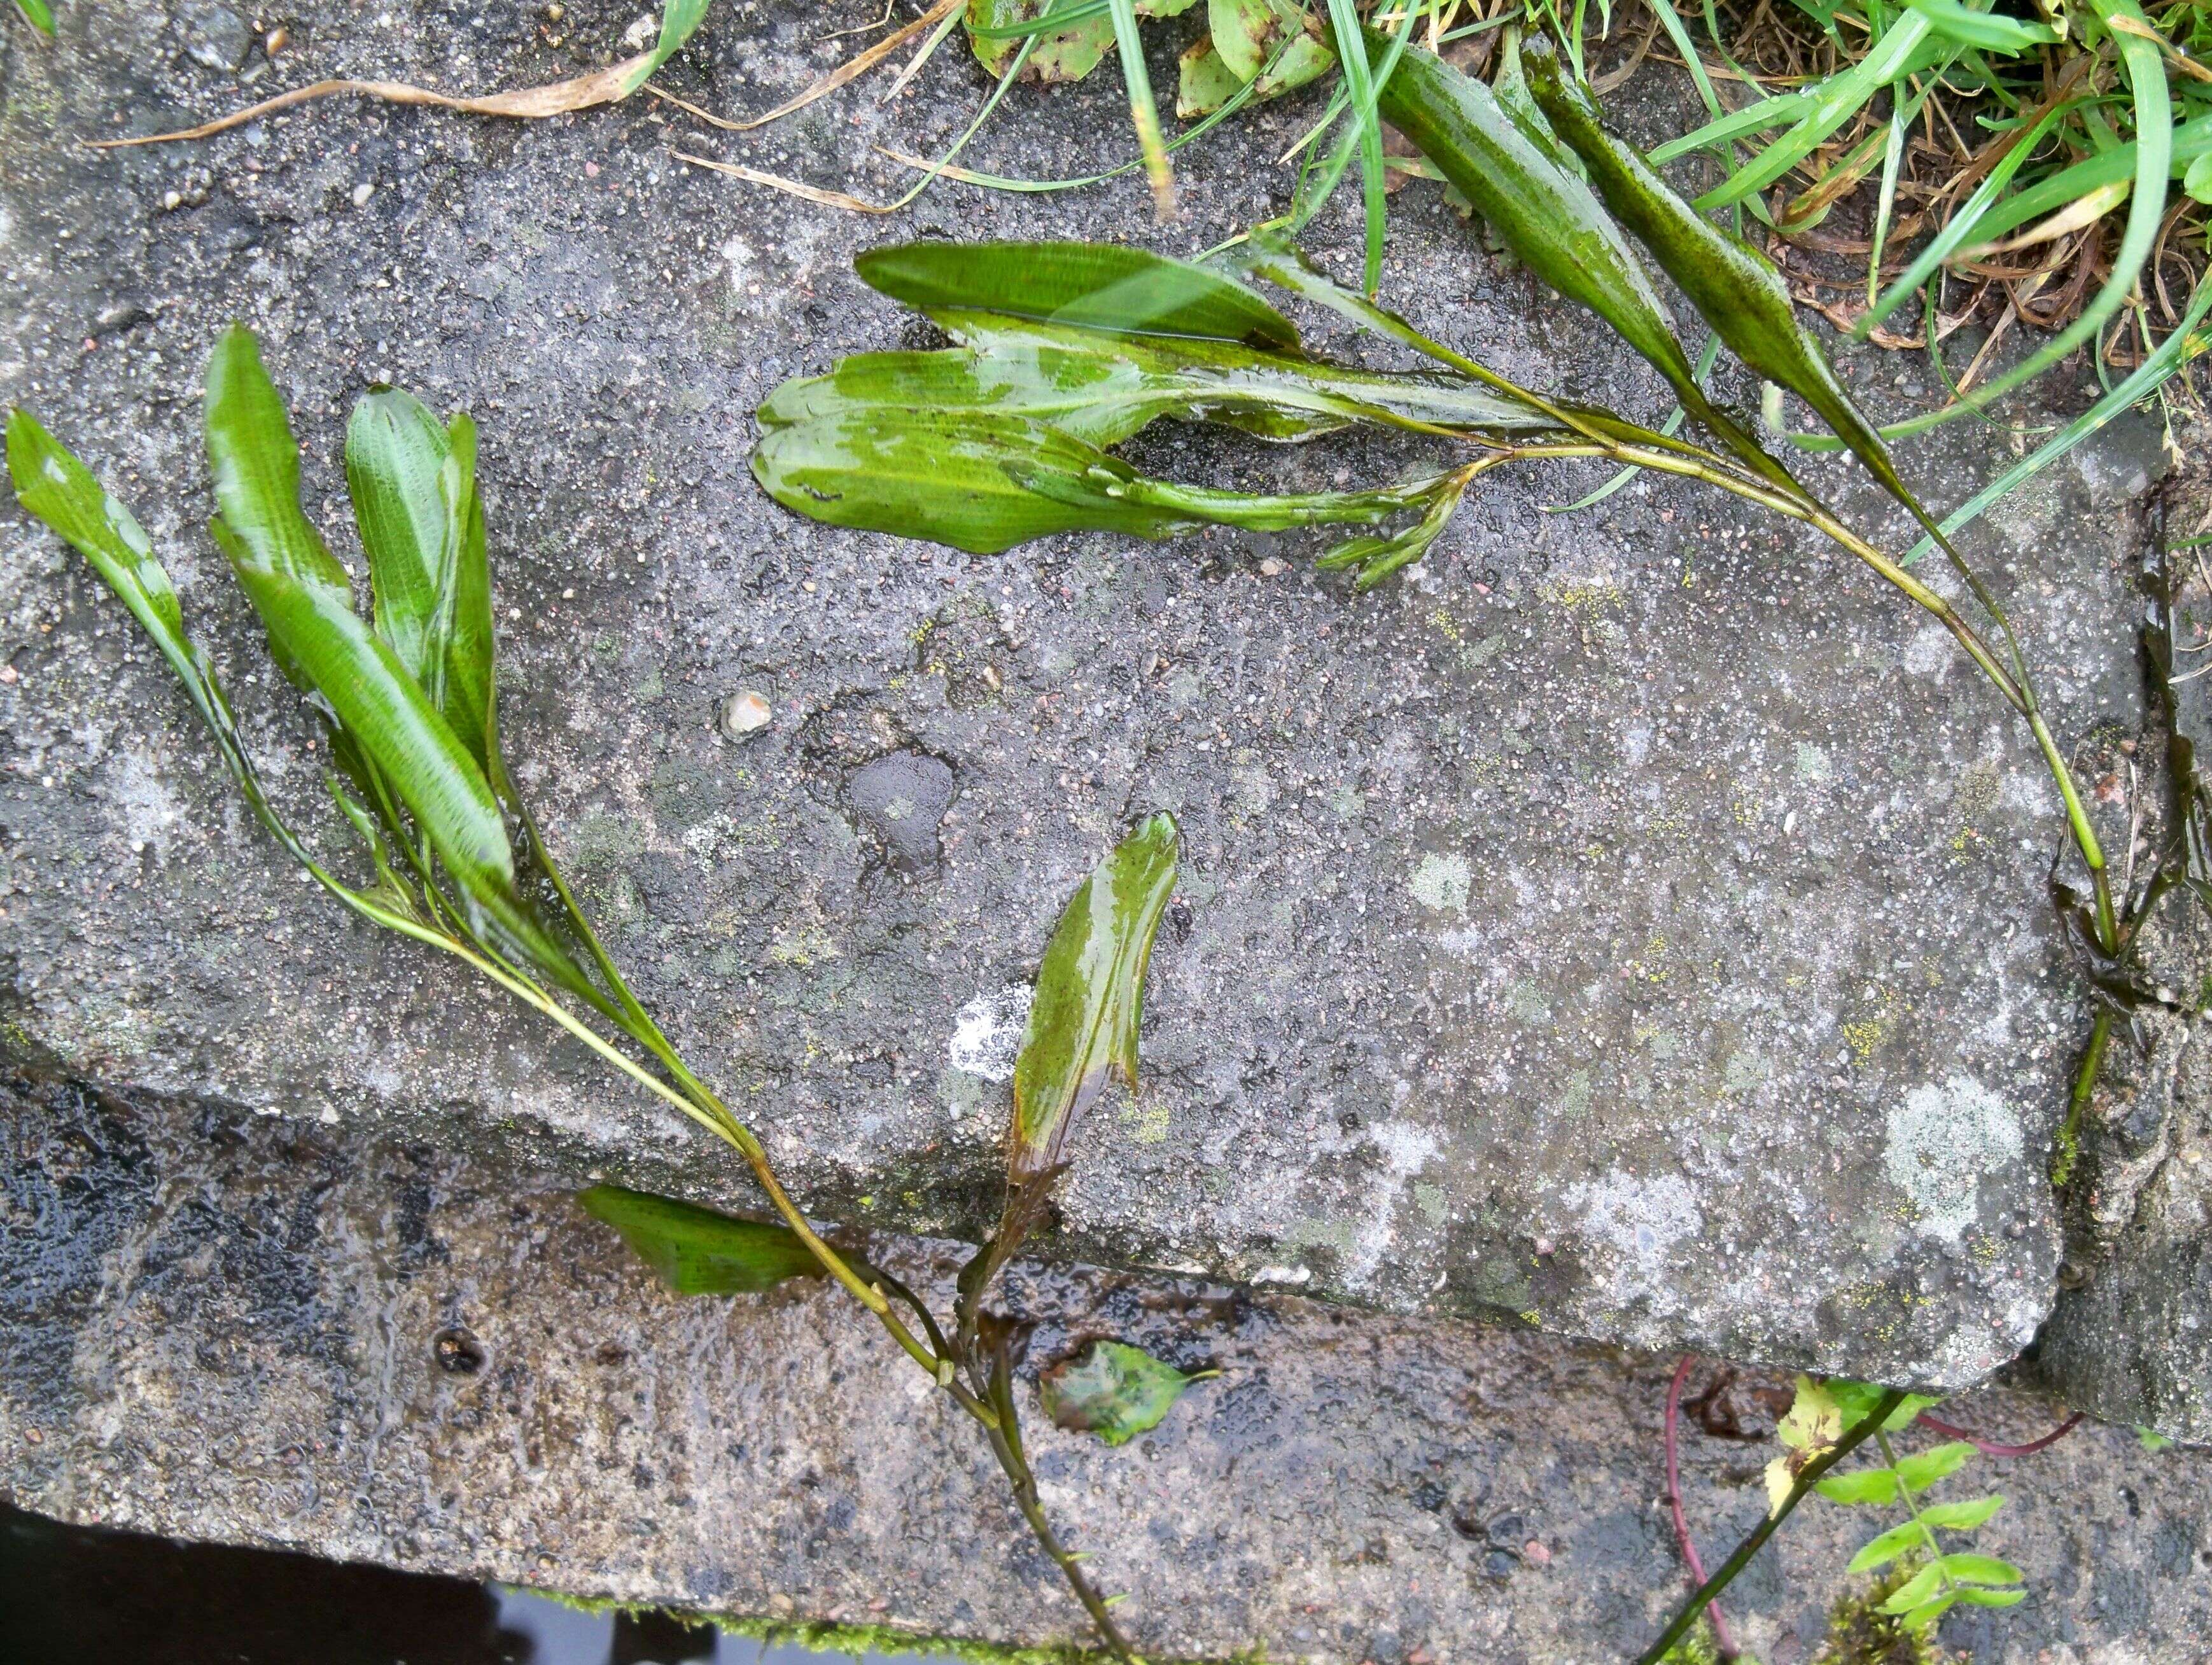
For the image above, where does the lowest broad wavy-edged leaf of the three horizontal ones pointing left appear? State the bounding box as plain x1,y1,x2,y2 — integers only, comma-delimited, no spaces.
752,409,1438,555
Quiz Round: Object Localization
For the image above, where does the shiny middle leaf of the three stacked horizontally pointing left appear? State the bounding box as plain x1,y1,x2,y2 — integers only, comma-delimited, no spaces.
759,323,1557,449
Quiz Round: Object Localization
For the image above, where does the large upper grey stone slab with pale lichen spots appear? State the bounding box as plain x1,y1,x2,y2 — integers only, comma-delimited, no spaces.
0,0,2159,1382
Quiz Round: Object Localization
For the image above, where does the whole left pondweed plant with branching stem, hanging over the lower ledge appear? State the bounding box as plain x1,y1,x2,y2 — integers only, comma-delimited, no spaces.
6,327,1181,1654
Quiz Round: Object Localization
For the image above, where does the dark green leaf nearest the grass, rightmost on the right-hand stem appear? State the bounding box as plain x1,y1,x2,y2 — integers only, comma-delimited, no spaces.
1529,40,1936,529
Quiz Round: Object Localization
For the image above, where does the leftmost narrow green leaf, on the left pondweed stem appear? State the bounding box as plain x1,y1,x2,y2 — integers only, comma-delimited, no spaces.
6,409,312,867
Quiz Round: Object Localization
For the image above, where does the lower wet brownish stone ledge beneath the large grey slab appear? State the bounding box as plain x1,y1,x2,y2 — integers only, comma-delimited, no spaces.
13,1090,2212,1665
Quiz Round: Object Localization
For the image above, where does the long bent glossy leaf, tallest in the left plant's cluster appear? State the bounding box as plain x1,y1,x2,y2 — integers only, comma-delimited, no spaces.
208,327,542,942
